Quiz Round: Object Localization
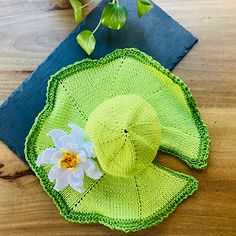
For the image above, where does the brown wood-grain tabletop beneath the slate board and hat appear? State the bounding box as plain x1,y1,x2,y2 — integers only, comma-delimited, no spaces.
0,0,236,236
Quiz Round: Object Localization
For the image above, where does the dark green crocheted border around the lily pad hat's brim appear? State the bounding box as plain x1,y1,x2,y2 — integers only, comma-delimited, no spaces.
25,48,210,232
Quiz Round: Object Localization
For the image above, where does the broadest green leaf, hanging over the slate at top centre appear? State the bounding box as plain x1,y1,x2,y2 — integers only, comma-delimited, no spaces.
101,3,127,30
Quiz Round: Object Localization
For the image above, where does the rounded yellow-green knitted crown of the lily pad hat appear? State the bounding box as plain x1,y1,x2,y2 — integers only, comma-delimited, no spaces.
86,95,161,176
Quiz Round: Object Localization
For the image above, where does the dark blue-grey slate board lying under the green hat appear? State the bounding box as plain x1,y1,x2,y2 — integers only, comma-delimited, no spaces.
0,0,197,164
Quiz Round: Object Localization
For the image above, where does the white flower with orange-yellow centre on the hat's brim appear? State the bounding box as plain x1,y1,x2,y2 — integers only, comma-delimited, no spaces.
36,124,102,192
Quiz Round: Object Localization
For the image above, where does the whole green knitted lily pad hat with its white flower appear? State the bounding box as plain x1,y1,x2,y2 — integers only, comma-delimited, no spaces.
25,49,210,231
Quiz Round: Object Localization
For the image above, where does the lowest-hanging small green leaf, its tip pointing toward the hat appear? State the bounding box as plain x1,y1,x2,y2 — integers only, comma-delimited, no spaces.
76,30,96,55
